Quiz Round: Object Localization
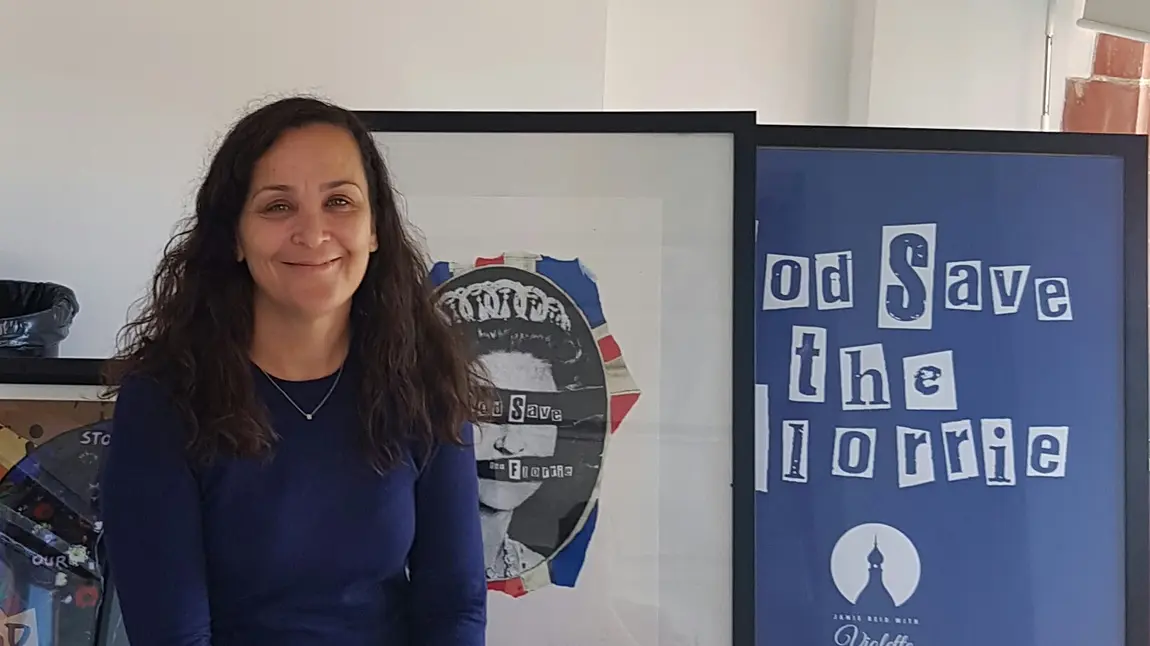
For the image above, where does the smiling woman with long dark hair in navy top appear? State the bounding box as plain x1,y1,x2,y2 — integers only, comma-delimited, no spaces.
101,99,486,646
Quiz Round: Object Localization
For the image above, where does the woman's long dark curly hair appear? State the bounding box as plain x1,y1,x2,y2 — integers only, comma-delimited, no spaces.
101,97,486,471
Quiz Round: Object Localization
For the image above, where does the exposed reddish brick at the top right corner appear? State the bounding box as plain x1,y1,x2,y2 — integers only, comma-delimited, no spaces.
1063,33,1150,134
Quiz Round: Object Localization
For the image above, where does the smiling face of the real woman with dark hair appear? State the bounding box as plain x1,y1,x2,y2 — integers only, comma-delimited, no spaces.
237,124,378,316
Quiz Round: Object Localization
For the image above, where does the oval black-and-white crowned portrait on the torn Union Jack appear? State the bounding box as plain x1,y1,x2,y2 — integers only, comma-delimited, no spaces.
439,266,608,580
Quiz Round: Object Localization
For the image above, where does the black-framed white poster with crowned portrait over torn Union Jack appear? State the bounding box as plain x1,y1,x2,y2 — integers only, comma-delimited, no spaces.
360,113,754,646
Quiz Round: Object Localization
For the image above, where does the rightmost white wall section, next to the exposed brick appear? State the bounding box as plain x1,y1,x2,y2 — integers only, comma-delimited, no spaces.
850,0,1095,130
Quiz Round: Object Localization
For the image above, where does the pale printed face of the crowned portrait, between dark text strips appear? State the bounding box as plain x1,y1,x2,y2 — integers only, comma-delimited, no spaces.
475,352,559,512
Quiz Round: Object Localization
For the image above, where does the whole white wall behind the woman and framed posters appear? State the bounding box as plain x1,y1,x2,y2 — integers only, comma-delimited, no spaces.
0,0,1089,356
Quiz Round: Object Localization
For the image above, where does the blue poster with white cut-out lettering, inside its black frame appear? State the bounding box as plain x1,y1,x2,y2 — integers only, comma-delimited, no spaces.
756,148,1125,646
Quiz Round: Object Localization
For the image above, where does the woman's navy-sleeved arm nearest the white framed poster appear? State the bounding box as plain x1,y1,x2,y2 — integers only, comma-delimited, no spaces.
409,424,488,646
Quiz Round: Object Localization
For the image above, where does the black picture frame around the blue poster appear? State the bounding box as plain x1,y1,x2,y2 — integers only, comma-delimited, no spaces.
754,125,1150,646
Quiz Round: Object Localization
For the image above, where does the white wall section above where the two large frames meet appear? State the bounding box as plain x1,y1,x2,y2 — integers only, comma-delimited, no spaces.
604,0,856,124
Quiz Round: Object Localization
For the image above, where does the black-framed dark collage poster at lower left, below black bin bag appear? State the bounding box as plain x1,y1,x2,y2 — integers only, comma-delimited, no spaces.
0,359,113,646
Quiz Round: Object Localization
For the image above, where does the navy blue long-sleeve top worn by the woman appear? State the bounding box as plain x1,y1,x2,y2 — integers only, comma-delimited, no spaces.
101,368,486,646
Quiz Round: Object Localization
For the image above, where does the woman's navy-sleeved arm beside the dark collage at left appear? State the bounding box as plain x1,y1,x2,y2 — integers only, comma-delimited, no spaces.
100,379,212,646
